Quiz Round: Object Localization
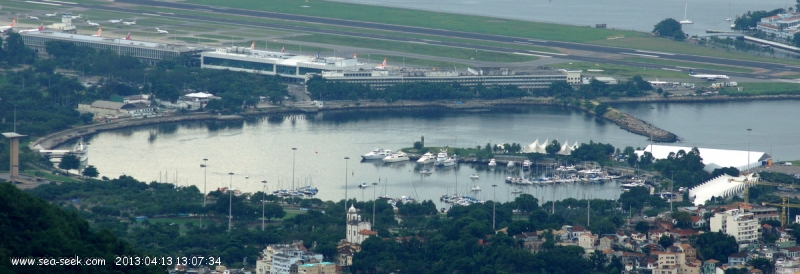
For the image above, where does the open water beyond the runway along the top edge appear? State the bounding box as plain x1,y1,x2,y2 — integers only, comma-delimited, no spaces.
332,0,794,34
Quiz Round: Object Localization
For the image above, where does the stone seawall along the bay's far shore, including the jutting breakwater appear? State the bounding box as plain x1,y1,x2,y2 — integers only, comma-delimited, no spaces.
29,95,800,150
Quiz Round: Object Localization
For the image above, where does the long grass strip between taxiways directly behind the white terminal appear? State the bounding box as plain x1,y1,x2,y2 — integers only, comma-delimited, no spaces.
285,34,538,62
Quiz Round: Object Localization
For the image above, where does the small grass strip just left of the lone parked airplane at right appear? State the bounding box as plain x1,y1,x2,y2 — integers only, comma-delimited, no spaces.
548,62,692,81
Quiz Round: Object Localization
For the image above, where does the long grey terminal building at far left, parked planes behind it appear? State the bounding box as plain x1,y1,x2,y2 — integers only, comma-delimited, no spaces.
21,31,199,65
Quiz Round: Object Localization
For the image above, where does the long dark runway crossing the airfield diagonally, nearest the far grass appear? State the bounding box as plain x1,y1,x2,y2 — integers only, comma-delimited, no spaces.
48,0,788,79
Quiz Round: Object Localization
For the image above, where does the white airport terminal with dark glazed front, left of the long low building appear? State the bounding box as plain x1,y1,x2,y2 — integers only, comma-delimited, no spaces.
200,47,371,82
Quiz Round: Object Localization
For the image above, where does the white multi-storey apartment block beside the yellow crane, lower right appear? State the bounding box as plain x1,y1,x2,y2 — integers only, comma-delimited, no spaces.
709,209,760,245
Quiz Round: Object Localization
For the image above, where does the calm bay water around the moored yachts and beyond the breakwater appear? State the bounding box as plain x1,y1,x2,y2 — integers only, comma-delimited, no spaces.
73,101,800,206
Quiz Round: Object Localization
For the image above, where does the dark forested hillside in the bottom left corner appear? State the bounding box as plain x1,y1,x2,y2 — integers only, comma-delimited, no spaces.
0,183,166,273
